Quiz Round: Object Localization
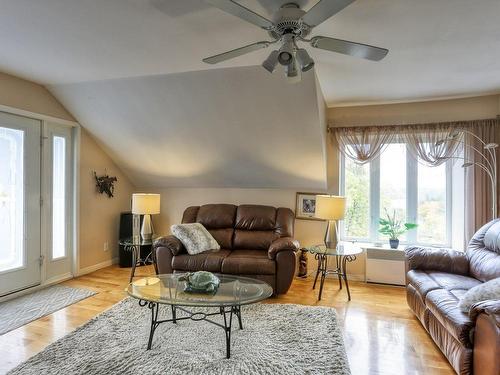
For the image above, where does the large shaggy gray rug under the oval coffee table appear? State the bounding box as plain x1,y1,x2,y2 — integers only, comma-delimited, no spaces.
9,298,350,375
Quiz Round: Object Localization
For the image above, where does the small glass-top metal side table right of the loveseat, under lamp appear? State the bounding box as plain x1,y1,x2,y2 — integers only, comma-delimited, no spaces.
308,242,363,301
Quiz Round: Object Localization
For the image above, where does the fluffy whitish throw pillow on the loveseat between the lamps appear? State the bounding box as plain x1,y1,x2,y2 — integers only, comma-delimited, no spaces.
170,223,220,255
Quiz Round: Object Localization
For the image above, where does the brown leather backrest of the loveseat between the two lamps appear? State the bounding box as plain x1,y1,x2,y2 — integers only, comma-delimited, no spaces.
182,204,294,250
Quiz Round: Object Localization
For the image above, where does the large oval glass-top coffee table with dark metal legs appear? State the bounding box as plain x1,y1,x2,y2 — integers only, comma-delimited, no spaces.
126,273,273,358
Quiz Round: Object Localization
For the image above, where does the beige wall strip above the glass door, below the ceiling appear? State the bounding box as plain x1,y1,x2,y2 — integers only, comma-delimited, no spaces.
0,73,75,121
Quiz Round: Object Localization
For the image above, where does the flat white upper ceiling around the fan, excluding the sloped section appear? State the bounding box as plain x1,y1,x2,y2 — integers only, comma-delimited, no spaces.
0,0,500,106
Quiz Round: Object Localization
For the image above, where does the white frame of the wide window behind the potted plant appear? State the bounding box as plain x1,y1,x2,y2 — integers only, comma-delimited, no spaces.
339,142,453,247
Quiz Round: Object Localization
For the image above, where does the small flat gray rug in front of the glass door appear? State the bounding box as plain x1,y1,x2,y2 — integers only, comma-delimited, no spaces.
0,285,96,335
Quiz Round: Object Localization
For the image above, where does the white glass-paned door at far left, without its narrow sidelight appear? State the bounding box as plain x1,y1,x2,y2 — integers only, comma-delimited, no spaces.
0,113,41,296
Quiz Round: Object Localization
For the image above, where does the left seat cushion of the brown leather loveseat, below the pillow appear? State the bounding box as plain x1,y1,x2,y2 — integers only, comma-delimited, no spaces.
172,250,231,272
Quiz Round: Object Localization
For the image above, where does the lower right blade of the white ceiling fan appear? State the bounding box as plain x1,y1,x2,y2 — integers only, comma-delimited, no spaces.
311,36,389,61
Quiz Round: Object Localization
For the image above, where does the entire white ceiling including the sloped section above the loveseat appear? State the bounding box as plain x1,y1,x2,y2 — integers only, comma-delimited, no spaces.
0,0,500,189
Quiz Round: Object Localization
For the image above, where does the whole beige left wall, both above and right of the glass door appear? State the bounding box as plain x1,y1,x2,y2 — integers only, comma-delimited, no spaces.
0,73,137,269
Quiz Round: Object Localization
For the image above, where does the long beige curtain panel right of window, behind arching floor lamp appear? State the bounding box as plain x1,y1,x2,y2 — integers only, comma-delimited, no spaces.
465,119,500,239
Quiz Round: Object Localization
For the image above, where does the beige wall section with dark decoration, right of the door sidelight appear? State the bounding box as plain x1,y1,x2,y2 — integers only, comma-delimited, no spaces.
79,129,134,269
